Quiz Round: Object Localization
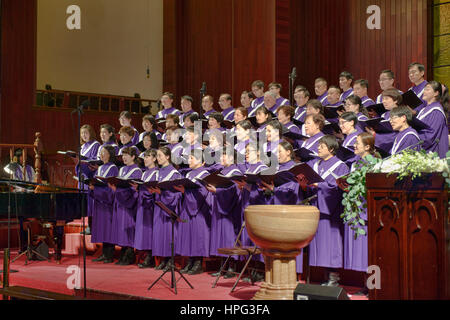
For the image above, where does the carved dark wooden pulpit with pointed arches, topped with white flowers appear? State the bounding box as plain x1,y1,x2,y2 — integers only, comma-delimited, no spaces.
366,173,450,300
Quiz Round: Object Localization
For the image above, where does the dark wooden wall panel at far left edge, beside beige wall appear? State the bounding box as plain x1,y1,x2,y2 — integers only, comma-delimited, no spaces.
0,0,37,143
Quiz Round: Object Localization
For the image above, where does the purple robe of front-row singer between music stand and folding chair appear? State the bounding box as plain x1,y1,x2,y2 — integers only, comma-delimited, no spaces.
175,167,212,257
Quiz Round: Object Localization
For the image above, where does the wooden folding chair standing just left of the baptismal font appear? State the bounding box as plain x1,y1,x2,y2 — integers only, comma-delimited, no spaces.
212,221,261,292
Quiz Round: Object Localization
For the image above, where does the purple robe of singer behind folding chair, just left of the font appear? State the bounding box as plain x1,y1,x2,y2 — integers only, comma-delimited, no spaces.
210,165,242,256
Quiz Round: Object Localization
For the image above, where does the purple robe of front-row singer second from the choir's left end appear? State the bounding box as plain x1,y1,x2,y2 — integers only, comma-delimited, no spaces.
89,162,119,244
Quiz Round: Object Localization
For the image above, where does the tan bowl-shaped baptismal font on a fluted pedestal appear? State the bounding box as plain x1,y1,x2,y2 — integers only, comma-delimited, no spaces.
245,205,320,300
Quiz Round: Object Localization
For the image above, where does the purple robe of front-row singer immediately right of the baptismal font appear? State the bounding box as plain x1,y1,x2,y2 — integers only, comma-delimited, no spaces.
309,157,349,268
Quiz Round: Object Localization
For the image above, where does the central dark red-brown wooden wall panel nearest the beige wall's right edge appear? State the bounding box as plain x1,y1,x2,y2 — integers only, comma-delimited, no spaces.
164,0,278,110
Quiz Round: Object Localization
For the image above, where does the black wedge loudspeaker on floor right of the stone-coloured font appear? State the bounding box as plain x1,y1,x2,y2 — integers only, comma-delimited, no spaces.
294,283,349,300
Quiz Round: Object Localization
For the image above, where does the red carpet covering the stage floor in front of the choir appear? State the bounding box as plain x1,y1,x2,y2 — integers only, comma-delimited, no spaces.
2,252,367,300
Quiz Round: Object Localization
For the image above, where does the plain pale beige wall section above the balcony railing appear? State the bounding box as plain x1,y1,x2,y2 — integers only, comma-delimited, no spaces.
36,0,163,99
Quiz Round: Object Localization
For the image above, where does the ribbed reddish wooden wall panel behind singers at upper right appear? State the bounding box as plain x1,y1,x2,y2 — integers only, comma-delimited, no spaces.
292,0,428,97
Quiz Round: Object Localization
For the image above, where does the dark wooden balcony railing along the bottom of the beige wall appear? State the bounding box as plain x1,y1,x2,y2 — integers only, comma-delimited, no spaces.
35,89,157,114
